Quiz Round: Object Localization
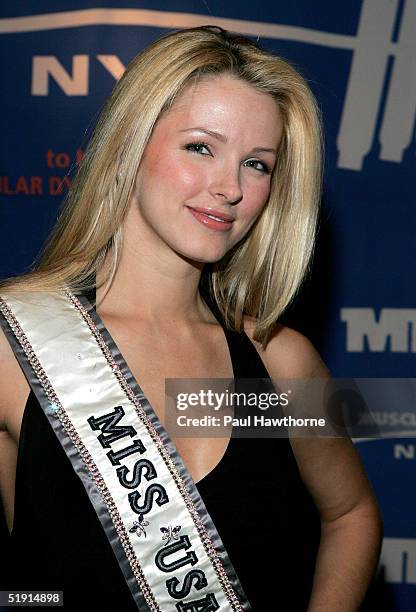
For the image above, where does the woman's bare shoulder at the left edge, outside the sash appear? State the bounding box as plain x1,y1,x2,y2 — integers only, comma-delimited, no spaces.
0,328,29,431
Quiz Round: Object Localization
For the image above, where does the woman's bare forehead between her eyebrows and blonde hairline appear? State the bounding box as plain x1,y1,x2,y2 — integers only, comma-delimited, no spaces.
160,75,282,146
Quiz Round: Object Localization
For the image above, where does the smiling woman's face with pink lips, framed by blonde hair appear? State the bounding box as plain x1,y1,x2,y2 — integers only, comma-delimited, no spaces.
134,75,282,263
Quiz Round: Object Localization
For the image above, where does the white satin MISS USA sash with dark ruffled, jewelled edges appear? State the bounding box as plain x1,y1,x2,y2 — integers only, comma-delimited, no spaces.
0,291,251,612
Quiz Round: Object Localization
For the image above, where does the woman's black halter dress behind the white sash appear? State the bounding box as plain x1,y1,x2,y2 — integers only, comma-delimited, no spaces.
0,298,320,612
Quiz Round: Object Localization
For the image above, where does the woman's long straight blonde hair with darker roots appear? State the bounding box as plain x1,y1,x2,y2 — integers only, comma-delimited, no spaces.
3,26,322,345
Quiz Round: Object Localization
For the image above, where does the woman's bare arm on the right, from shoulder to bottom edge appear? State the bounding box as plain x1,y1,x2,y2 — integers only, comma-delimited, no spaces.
246,324,382,612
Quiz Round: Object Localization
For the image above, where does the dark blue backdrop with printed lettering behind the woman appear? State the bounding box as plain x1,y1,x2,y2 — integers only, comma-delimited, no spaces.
0,0,416,612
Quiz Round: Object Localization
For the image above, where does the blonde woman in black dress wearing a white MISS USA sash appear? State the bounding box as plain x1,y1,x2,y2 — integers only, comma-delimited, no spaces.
0,26,381,612
